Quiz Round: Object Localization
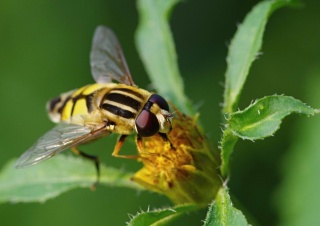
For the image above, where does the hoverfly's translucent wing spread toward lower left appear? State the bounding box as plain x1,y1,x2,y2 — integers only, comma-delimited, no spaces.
16,123,107,168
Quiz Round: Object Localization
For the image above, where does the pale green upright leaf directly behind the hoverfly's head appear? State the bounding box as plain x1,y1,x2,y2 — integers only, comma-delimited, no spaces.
136,0,194,115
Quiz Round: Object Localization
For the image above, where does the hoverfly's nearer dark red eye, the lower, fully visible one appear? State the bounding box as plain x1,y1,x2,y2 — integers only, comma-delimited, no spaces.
136,110,160,137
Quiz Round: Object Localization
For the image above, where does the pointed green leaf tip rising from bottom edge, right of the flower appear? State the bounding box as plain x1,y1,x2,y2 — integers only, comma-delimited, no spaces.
204,188,248,226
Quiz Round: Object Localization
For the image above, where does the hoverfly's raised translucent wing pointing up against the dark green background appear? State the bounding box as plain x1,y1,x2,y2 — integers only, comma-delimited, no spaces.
90,25,135,86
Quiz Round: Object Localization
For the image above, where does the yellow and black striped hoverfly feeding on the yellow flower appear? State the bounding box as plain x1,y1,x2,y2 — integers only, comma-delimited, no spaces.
16,26,173,185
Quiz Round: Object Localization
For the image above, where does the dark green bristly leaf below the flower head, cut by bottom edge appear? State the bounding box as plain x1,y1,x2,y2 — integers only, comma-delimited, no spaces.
128,205,199,226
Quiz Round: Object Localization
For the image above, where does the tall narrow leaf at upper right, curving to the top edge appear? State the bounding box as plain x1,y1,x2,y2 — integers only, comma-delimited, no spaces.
223,0,292,113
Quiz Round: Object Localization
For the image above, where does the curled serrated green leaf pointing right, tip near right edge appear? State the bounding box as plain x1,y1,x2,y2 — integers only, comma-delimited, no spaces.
227,95,319,140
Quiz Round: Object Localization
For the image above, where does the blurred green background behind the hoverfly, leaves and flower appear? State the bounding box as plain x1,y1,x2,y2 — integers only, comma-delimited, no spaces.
0,0,320,226
